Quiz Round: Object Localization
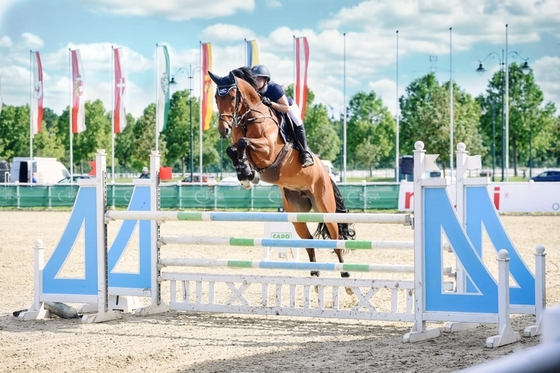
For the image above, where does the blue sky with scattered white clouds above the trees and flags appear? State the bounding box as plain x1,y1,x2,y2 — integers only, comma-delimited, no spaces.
0,0,560,118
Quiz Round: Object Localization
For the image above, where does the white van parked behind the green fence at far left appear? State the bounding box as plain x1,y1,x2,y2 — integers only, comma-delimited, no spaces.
10,157,70,184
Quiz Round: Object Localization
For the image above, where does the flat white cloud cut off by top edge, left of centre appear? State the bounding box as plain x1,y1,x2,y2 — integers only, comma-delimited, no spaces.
85,0,255,21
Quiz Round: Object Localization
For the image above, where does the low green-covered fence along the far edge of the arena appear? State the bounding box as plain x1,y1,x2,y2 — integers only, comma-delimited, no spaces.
0,183,399,211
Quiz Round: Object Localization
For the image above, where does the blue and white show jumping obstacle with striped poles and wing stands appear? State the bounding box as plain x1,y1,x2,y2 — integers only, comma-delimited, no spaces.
20,142,546,347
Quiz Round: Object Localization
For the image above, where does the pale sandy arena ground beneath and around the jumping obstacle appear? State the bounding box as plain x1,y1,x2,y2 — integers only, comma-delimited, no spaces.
0,211,560,373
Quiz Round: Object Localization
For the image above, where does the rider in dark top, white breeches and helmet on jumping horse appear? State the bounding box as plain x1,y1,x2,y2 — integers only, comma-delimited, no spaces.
251,65,314,168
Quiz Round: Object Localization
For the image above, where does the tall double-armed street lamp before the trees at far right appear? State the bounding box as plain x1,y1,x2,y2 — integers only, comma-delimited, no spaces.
476,24,531,181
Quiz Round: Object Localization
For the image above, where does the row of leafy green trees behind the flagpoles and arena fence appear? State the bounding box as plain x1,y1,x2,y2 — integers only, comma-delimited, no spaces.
0,64,560,175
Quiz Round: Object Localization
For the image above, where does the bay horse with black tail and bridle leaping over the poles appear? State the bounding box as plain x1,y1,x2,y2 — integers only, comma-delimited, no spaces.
208,67,355,282
